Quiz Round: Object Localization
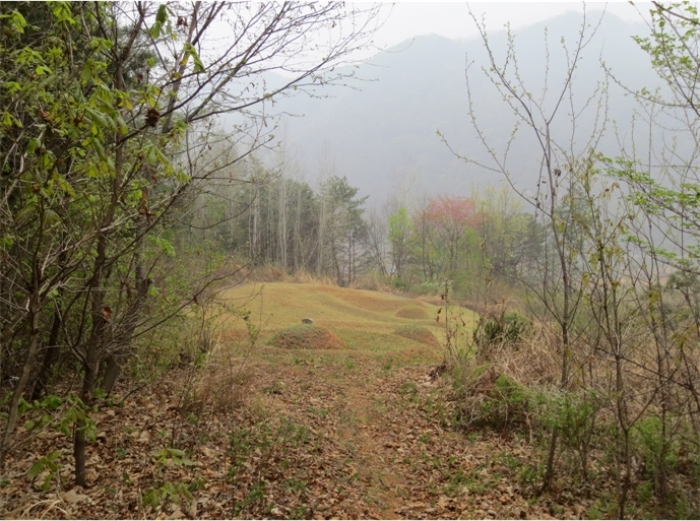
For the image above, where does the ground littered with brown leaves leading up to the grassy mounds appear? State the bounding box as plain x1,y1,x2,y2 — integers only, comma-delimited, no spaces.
0,287,591,519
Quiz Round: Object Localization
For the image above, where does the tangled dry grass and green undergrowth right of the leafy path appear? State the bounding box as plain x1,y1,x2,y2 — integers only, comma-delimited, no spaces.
438,282,700,518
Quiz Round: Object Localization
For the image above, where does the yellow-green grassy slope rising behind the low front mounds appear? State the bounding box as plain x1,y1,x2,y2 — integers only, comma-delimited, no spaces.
215,282,477,361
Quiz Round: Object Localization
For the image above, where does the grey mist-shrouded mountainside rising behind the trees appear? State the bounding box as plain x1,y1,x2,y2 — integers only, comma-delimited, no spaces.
228,11,660,200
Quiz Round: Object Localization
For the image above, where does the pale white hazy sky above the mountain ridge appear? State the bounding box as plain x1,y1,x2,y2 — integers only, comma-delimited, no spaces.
375,1,651,46
